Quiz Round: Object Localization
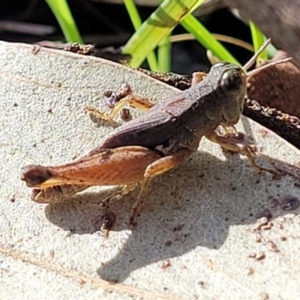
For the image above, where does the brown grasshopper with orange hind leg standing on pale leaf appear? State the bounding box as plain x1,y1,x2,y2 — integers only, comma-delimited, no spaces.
21,40,286,225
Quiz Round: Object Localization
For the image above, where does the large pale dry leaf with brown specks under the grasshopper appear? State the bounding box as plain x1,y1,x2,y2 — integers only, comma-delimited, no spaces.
0,42,300,299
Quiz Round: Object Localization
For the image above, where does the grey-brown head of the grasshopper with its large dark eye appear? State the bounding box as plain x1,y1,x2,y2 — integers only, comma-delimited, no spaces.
212,63,247,126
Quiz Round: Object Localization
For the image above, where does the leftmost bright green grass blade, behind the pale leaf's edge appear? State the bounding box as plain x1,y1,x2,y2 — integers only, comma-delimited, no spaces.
46,0,83,44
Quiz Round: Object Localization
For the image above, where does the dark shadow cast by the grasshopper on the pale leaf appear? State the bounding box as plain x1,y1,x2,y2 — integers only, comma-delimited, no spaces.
46,152,298,282
